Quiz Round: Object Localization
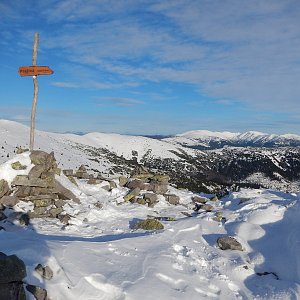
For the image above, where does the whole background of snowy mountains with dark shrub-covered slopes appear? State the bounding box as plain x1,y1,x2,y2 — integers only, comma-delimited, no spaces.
0,120,300,192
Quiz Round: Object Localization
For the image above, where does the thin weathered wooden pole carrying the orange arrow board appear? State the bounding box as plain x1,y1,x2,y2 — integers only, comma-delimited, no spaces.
29,32,39,151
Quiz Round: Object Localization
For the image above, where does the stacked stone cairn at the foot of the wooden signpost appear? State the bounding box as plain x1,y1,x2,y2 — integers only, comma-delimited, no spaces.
0,151,80,225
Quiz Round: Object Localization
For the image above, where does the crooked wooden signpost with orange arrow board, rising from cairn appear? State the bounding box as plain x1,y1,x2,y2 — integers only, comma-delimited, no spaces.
19,32,53,151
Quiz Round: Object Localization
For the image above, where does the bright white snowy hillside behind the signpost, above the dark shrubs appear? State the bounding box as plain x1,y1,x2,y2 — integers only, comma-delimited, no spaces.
0,120,195,166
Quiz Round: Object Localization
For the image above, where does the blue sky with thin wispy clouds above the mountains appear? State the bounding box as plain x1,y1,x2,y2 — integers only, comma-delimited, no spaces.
0,0,300,134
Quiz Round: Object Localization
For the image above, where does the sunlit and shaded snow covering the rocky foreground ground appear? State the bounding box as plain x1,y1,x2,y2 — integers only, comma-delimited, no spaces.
0,153,300,300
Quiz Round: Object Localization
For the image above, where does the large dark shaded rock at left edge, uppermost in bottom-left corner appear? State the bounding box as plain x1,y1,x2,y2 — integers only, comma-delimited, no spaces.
0,253,27,283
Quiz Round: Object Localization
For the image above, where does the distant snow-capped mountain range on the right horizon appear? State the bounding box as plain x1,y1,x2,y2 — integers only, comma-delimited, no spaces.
163,130,300,149
